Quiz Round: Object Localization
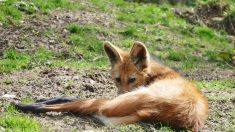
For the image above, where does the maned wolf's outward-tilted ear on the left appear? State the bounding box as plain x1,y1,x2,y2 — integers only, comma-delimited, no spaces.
104,41,122,67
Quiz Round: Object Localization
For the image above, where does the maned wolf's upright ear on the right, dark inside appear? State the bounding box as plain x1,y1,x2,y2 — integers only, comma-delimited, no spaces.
130,41,150,70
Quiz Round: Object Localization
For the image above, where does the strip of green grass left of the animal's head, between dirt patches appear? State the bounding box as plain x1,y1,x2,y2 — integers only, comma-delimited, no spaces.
0,44,108,73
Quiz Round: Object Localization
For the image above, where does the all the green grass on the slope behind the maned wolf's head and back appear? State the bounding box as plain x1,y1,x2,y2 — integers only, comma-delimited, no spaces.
0,0,233,72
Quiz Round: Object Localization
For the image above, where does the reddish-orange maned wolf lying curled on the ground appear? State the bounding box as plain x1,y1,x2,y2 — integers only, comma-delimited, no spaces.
14,42,208,132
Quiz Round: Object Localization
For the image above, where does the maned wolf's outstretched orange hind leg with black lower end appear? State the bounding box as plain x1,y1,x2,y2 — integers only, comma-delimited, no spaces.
14,91,151,124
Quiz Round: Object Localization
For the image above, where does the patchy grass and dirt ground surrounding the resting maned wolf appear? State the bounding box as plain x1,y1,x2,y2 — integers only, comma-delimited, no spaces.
0,0,235,131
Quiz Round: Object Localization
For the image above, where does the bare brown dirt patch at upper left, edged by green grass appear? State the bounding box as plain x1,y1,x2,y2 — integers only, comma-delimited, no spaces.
0,7,125,57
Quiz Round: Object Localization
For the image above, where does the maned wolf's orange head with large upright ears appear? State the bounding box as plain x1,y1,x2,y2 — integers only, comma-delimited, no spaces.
104,42,150,93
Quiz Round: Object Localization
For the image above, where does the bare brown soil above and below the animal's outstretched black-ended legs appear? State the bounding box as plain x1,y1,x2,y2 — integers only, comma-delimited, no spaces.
0,69,117,131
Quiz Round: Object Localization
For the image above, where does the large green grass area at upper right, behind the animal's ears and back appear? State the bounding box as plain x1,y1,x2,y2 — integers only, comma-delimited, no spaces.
84,0,233,70
